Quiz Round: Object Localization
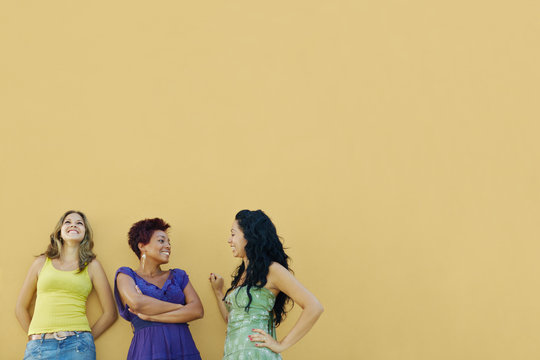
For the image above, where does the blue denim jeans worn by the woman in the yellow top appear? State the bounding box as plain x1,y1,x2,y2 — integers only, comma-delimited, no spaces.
24,331,96,360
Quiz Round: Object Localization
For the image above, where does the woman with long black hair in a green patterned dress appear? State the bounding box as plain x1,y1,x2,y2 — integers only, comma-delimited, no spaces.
210,210,323,360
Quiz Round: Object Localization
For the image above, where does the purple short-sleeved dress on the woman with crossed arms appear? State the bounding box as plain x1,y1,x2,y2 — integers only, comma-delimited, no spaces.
114,267,201,360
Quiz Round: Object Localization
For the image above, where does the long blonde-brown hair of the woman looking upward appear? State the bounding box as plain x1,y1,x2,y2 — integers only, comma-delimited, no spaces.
41,210,96,272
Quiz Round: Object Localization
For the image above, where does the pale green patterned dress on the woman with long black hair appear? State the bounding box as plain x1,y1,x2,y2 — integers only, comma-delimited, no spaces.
223,287,281,360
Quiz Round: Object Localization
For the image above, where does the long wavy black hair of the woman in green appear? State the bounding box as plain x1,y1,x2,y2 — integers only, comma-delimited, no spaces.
223,210,294,326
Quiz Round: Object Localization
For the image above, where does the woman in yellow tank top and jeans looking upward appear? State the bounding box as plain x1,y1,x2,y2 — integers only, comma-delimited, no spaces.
15,210,117,360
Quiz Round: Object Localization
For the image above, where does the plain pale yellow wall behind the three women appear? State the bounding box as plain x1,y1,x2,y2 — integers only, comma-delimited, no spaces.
0,0,540,360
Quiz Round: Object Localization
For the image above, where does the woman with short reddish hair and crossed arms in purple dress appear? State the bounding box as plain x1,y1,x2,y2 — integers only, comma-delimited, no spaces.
114,218,204,360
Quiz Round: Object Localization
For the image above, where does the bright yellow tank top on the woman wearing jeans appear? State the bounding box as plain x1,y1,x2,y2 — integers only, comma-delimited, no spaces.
28,258,92,335
